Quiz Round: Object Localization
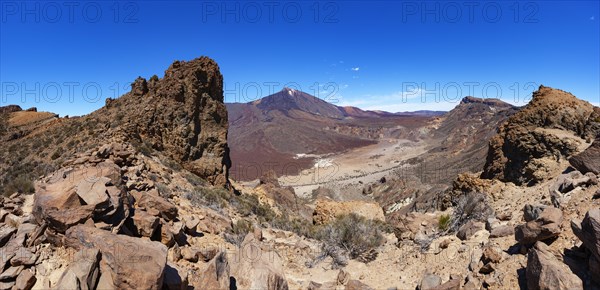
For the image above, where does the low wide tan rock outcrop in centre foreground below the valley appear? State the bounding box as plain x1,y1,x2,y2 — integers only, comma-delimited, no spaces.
313,199,385,225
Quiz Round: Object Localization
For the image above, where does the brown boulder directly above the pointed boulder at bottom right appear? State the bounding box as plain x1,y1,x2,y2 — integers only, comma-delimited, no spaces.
515,207,563,245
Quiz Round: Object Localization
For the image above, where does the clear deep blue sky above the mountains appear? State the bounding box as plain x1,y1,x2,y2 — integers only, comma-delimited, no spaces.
0,1,600,115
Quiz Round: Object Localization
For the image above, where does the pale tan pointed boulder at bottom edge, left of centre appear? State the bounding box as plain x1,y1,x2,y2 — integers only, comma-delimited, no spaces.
232,233,288,290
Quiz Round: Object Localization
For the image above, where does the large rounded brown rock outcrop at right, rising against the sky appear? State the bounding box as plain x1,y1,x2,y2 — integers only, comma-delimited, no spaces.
482,86,597,184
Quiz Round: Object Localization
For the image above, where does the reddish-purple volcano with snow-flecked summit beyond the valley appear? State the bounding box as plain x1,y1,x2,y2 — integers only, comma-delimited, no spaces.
226,88,438,180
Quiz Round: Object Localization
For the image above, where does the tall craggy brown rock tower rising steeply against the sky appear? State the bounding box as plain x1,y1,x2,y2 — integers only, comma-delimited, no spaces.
103,57,231,185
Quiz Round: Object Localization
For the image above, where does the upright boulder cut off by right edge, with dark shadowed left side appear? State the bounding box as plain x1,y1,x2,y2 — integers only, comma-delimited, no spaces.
571,208,600,261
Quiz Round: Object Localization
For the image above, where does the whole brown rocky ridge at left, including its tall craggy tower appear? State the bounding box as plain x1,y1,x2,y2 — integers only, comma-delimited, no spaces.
0,57,231,194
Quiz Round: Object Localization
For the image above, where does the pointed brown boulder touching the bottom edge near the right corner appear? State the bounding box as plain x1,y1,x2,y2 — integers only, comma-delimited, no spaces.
526,242,583,290
